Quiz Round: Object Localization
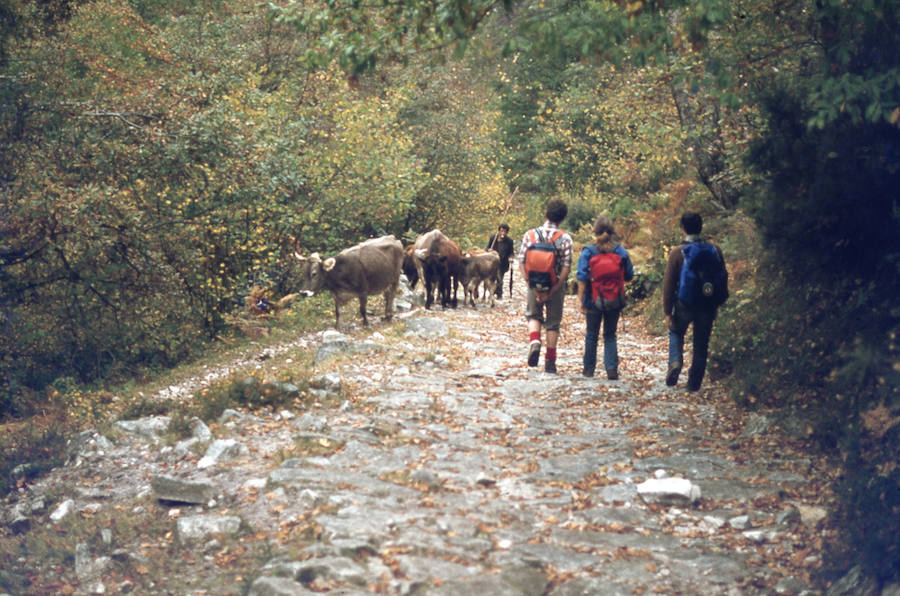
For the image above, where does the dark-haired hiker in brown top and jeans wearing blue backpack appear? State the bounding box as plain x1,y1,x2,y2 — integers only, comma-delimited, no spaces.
663,212,728,391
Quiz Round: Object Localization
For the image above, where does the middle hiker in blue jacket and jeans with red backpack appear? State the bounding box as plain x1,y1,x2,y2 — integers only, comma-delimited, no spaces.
575,216,634,381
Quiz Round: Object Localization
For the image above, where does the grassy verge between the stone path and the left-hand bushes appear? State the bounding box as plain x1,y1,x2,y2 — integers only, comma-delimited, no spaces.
0,295,334,496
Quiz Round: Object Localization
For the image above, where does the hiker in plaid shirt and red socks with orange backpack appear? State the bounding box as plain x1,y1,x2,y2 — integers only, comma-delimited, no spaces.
518,199,572,373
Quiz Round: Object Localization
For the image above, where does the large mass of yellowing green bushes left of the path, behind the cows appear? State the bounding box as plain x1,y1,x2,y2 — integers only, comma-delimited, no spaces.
0,1,426,415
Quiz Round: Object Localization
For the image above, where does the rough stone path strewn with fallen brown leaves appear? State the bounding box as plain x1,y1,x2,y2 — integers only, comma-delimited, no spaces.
2,286,826,596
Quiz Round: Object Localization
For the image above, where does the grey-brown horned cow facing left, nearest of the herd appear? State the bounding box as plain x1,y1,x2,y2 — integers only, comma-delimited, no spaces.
294,236,403,328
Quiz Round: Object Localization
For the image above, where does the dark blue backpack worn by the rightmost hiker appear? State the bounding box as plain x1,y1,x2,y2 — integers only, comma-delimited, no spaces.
678,241,728,308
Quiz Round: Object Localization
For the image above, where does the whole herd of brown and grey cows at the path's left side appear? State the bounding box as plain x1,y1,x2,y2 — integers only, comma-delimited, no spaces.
295,230,500,327
